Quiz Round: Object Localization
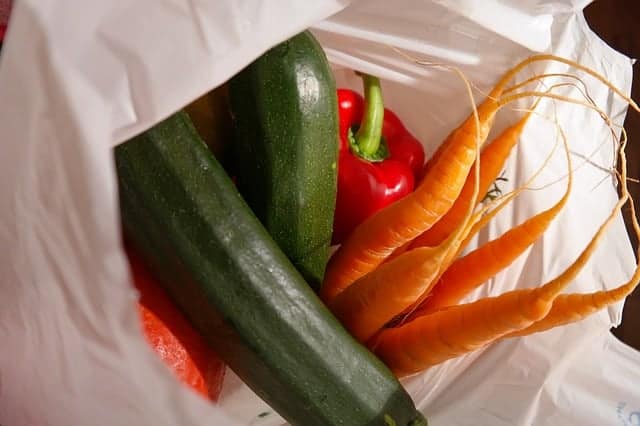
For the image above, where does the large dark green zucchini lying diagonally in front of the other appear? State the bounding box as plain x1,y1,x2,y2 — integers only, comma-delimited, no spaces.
115,112,426,426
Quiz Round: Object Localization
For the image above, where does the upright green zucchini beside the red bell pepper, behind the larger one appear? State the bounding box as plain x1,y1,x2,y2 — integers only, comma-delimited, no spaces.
229,31,338,290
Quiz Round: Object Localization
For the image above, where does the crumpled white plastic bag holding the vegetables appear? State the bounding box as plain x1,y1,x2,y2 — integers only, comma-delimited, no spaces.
0,0,640,426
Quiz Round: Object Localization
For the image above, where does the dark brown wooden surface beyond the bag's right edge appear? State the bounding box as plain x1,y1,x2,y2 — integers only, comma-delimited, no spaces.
585,0,640,350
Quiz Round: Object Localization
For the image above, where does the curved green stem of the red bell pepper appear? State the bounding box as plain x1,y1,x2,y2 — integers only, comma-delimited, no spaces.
355,74,384,155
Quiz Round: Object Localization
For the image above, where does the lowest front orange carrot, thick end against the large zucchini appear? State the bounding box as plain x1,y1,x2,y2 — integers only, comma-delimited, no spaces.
368,176,629,376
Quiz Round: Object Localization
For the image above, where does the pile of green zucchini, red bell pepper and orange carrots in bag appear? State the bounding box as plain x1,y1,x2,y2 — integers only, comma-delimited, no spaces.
115,32,640,426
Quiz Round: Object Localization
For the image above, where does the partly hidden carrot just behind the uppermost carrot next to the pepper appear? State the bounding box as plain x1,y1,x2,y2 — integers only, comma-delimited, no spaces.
410,107,535,248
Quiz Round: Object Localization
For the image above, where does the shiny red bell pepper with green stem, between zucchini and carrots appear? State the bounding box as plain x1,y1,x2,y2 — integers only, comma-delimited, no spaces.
333,75,424,244
